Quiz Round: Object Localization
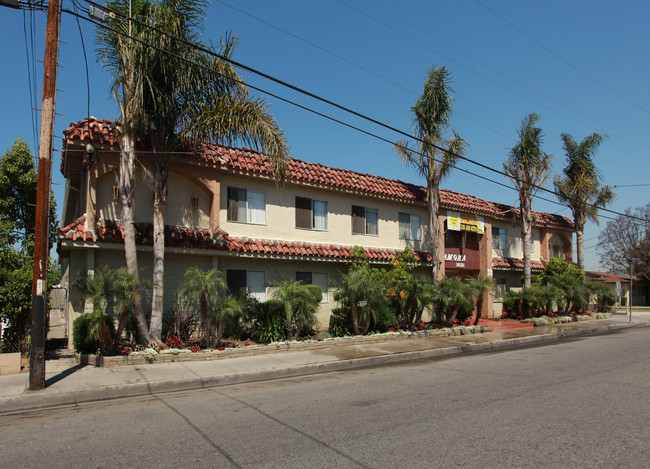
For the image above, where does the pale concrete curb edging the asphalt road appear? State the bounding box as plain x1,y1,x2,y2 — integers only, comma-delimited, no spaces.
0,323,650,415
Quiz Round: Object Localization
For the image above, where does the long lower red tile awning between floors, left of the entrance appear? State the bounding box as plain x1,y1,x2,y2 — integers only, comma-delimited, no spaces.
59,216,431,262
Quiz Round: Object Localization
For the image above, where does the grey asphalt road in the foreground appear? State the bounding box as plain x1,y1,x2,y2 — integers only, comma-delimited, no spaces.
0,328,650,468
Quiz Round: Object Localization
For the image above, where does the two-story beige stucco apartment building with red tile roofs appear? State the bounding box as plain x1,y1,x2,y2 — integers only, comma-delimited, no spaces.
58,118,573,344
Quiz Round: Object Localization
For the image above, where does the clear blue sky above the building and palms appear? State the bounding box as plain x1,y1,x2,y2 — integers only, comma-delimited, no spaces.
0,0,650,269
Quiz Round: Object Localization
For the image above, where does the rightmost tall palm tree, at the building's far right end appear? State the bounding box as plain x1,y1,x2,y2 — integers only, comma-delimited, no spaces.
554,133,616,270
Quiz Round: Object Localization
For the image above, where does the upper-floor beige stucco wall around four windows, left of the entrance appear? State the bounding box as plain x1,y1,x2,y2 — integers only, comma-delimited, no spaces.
220,176,428,250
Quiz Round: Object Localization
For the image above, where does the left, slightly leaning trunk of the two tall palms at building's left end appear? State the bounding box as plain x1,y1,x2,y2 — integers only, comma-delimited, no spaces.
119,124,149,344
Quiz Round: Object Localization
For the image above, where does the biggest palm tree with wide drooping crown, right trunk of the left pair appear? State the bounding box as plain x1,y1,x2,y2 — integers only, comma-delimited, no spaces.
98,0,288,341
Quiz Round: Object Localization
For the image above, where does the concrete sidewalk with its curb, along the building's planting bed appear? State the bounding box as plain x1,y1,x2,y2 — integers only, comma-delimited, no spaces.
0,313,650,415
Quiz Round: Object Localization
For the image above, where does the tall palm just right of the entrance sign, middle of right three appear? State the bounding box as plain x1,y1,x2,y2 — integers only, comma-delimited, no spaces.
503,114,551,288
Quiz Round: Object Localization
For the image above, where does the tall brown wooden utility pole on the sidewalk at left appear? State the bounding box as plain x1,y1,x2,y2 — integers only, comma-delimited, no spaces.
29,0,61,390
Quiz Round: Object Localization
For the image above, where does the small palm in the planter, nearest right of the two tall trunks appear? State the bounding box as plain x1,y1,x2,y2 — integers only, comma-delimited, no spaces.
178,267,228,343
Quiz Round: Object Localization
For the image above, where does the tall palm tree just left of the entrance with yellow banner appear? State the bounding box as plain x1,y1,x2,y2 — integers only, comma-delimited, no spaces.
393,67,467,280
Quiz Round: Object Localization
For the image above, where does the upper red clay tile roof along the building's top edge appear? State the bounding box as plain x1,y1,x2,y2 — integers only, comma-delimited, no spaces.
61,118,574,229
